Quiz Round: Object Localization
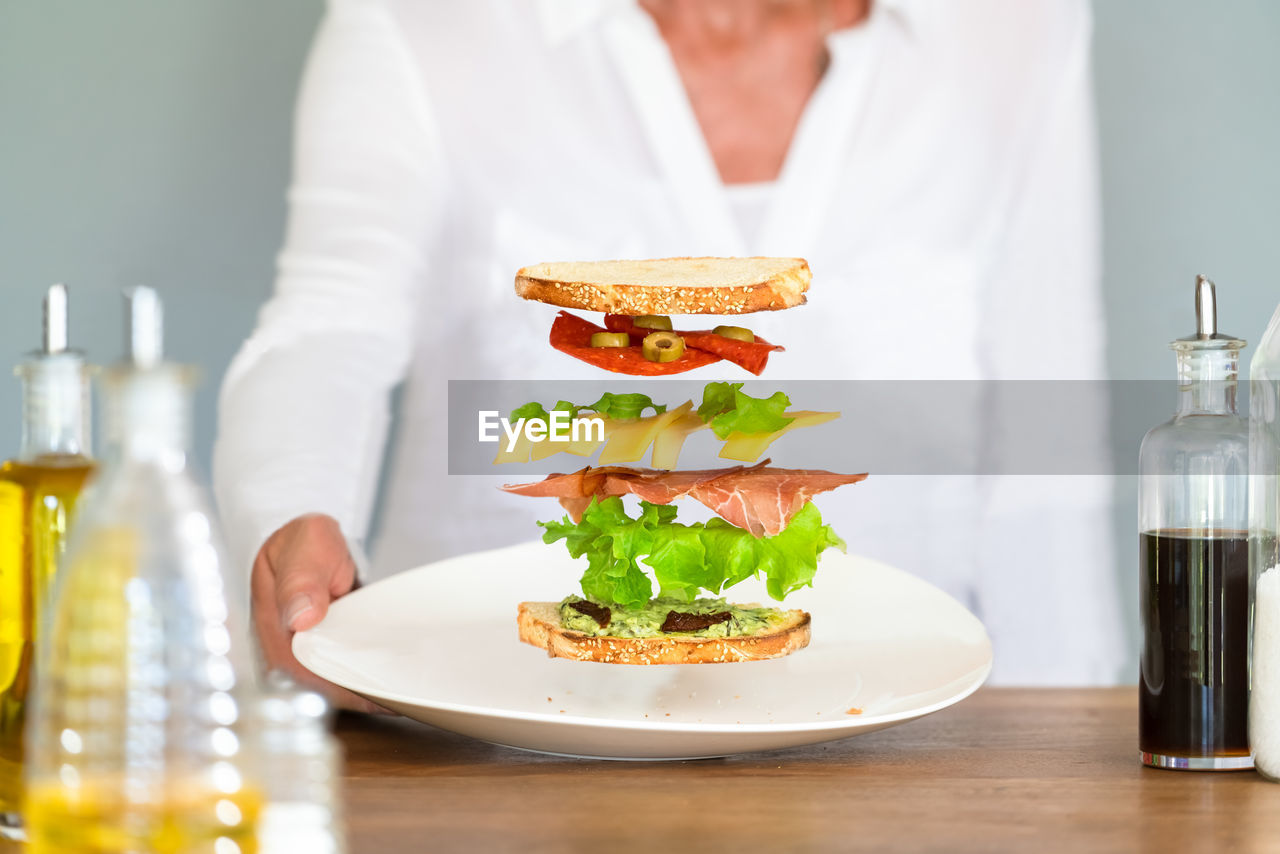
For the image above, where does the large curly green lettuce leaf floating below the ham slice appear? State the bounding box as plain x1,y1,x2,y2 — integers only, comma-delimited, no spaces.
538,497,845,608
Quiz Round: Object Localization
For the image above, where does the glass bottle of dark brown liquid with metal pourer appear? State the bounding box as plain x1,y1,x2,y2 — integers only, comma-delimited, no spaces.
1138,277,1253,771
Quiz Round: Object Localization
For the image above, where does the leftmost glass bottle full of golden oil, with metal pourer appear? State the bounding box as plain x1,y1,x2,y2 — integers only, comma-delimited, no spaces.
0,284,92,839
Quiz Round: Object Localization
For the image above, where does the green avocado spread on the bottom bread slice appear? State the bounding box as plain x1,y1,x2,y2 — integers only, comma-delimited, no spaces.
559,597,786,638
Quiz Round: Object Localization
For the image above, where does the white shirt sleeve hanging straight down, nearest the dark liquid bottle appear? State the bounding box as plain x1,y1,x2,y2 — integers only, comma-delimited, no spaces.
975,3,1126,684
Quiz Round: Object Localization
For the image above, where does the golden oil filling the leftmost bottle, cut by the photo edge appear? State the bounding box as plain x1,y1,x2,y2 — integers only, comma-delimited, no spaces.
0,455,92,813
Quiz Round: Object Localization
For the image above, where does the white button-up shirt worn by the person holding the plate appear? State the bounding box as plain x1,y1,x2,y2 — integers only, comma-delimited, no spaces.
214,0,1124,682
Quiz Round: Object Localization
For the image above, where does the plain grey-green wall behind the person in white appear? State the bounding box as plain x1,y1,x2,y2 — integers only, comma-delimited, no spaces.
0,0,1280,672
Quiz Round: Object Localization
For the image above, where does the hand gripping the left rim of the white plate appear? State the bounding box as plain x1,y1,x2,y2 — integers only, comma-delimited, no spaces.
250,515,387,713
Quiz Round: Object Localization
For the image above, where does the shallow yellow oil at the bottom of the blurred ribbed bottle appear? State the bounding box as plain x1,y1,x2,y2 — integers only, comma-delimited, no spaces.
26,781,262,854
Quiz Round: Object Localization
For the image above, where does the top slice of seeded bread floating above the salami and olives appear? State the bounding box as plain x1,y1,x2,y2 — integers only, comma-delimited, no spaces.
516,257,813,316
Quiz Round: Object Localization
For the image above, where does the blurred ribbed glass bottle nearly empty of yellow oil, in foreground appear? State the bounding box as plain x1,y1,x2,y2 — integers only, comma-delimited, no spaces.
26,288,261,854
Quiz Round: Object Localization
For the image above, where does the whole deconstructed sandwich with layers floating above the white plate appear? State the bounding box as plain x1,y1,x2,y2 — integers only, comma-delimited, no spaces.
498,257,867,665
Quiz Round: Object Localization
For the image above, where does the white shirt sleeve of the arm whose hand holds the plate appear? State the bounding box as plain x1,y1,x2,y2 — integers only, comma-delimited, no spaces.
214,0,445,571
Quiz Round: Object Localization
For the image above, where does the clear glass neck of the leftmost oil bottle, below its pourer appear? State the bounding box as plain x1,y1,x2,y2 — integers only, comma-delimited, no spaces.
17,352,90,461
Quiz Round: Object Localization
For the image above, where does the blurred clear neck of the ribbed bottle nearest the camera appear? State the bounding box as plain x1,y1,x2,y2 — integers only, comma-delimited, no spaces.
104,365,192,471
